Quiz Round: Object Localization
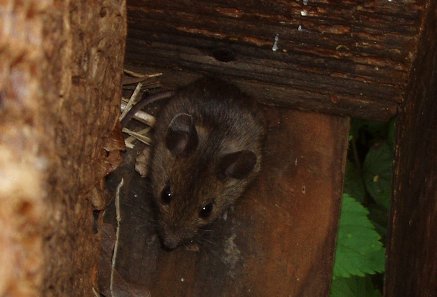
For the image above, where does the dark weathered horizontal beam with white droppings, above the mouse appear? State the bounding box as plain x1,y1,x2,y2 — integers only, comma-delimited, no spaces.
123,0,424,119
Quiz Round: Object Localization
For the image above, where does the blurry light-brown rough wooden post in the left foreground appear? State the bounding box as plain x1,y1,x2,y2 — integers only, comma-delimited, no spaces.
0,0,126,297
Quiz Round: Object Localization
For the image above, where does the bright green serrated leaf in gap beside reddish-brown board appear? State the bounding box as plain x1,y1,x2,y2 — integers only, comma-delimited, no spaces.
334,194,385,278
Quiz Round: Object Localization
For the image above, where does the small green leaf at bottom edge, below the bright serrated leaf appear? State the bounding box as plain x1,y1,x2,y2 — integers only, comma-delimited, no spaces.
330,277,382,297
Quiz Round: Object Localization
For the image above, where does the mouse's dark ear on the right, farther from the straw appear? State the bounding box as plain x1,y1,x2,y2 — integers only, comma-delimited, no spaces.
218,150,256,179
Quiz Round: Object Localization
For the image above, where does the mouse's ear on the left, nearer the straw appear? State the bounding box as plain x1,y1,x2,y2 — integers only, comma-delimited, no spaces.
165,113,198,157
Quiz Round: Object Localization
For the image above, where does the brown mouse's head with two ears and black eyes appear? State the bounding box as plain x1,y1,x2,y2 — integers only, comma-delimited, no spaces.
151,114,260,249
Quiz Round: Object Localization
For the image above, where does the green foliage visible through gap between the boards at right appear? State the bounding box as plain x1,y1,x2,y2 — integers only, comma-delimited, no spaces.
331,119,395,297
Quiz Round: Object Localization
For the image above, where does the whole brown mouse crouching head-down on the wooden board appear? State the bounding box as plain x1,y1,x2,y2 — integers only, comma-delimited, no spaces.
124,77,265,250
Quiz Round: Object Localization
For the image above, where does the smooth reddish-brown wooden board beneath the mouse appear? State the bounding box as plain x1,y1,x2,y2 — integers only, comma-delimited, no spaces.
108,108,348,297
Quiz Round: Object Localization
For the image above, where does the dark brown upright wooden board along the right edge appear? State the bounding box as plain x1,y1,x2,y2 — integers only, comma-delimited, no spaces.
385,1,437,297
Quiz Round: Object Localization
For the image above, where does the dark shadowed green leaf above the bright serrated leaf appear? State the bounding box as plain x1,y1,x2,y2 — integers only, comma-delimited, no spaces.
363,142,393,208
